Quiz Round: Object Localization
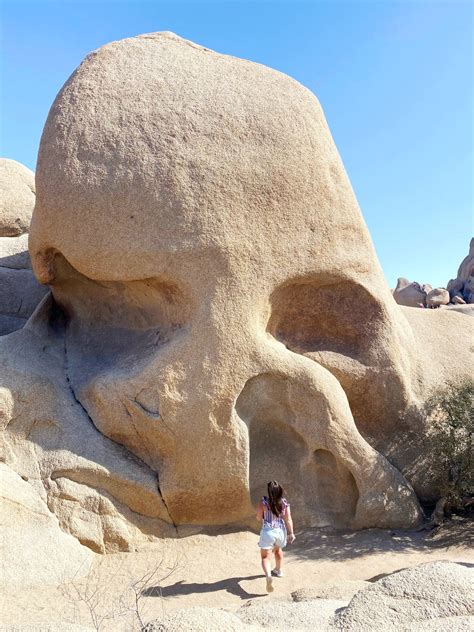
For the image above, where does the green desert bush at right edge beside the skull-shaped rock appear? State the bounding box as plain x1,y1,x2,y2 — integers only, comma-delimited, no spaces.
427,380,474,512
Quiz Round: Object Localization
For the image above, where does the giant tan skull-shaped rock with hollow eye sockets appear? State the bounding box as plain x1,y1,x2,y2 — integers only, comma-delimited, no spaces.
30,33,420,527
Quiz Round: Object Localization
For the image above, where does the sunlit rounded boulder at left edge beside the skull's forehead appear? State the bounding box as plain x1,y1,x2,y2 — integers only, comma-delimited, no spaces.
0,158,35,237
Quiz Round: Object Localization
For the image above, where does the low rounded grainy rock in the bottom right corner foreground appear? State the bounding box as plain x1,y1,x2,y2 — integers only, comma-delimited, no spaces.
333,562,474,631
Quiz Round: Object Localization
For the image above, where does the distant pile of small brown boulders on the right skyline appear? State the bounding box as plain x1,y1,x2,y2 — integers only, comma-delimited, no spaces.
393,238,474,308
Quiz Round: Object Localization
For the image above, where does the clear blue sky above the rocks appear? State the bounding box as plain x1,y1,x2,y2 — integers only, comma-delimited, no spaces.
0,0,473,287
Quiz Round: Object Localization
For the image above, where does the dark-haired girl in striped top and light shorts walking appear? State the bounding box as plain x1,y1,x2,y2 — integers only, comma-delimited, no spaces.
257,481,295,592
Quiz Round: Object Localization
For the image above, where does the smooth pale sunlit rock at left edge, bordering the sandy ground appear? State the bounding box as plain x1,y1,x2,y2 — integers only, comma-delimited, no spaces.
0,462,92,590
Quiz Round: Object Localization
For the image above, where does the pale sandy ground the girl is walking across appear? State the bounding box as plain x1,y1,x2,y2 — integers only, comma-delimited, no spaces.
0,523,474,632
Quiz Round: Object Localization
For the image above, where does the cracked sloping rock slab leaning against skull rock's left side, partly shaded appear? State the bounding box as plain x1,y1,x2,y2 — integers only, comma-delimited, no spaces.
0,297,176,552
